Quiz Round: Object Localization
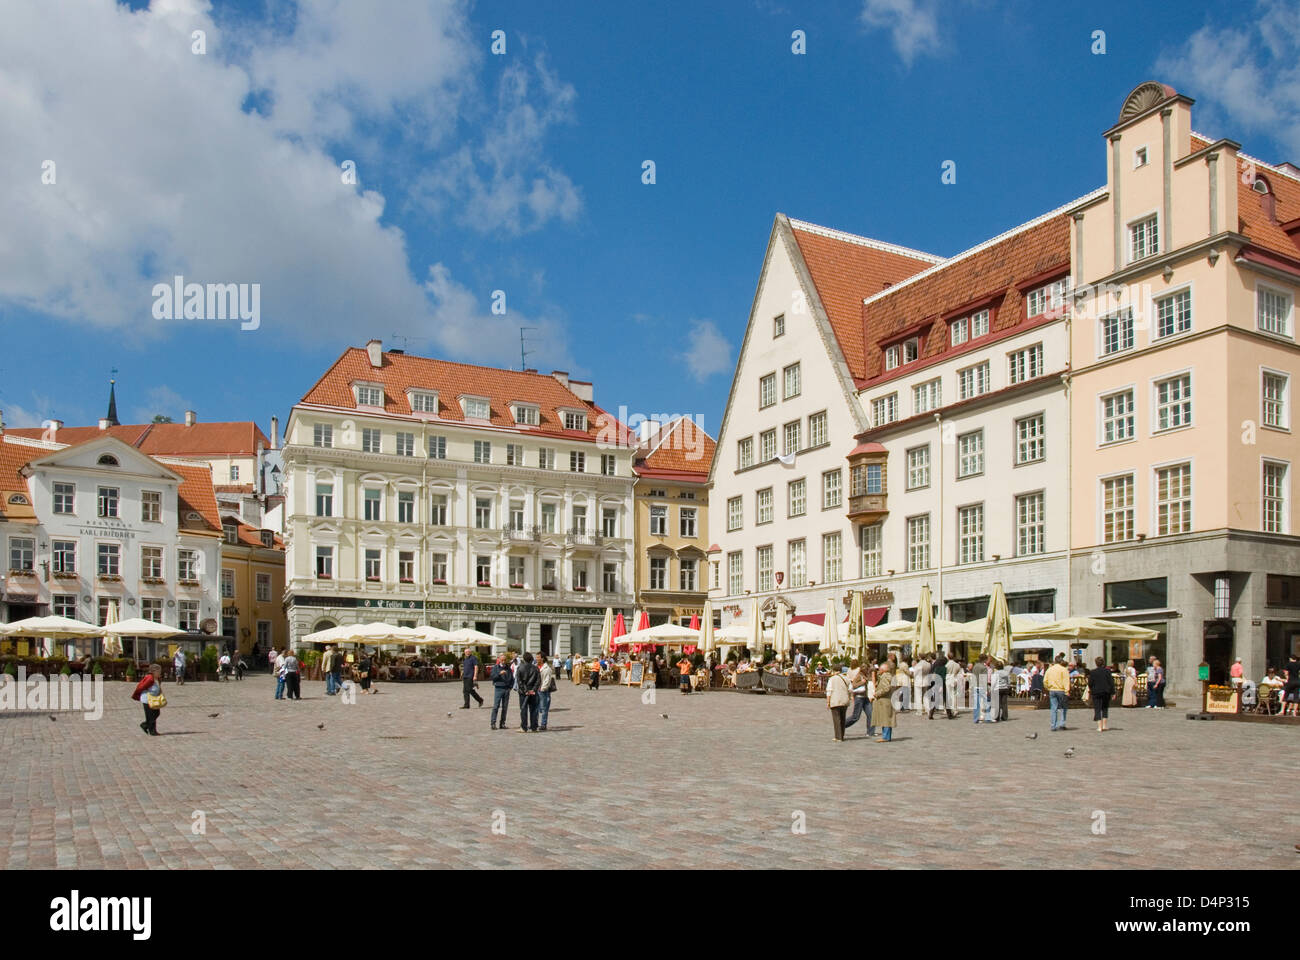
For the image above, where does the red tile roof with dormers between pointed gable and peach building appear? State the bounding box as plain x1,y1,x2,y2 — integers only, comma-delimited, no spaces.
859,212,1070,386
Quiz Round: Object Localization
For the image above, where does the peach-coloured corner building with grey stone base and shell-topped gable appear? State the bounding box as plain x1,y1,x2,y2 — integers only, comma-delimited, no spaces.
1071,83,1300,693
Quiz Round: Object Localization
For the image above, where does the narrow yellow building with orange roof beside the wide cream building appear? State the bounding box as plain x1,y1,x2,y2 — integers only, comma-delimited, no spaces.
629,418,714,627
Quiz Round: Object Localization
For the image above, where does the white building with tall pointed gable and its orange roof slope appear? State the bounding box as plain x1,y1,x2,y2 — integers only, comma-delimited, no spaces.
709,213,939,624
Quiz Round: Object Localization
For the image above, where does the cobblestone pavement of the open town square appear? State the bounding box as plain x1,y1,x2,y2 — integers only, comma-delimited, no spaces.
0,675,1300,869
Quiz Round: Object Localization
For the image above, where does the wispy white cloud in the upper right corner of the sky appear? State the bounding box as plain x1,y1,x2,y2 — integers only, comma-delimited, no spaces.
1154,0,1300,160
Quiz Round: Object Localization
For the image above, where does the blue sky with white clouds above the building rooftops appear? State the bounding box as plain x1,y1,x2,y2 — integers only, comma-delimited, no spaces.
0,0,1300,433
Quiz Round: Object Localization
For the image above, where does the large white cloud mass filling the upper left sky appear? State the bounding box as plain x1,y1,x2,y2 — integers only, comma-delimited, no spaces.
0,0,577,359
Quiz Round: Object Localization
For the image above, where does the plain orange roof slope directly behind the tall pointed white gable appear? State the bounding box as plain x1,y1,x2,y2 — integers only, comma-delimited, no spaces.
790,220,940,380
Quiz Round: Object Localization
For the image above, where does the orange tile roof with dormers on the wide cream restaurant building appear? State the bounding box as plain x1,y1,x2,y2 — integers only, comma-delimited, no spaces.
299,347,632,446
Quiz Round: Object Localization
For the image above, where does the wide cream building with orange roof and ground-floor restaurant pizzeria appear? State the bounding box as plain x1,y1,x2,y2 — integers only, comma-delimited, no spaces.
282,341,634,654
